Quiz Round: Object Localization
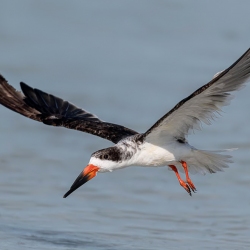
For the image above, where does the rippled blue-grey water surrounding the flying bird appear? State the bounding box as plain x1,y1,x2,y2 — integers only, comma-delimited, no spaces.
0,0,250,250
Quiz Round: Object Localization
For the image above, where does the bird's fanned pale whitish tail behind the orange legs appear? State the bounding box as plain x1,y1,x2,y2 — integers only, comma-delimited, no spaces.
181,148,236,174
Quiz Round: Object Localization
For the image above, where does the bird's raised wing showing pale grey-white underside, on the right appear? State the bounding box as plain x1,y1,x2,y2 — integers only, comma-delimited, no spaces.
142,49,250,143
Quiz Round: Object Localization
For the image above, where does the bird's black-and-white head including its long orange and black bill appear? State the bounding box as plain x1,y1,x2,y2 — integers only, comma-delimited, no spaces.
63,147,121,198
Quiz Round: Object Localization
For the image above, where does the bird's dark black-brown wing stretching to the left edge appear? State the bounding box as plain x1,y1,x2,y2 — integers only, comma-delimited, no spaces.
0,75,137,143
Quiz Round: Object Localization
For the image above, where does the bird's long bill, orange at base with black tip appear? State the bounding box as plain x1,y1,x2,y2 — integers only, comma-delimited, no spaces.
63,164,99,198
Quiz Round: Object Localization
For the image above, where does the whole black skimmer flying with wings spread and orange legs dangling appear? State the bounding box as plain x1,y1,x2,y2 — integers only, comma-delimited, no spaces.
0,49,250,198
